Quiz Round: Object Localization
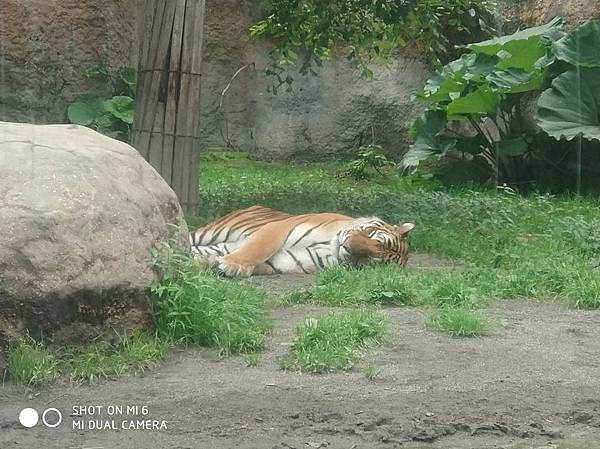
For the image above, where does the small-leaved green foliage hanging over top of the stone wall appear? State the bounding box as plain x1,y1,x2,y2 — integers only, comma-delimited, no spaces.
251,0,495,90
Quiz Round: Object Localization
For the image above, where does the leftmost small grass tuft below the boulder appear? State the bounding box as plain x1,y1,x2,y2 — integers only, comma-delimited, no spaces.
7,337,61,386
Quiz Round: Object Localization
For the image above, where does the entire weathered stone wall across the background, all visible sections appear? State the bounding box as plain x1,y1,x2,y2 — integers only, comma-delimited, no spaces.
0,0,600,159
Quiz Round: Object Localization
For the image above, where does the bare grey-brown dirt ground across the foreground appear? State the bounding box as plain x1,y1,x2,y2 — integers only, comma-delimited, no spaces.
0,254,600,449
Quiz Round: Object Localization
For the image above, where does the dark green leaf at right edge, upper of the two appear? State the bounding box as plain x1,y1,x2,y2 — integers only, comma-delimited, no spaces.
552,20,600,67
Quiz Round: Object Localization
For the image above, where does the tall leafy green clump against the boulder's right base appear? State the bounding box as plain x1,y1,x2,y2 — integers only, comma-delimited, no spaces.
151,242,271,354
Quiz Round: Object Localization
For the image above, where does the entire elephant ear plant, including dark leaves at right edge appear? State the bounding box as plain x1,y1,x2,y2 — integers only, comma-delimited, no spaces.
402,18,600,184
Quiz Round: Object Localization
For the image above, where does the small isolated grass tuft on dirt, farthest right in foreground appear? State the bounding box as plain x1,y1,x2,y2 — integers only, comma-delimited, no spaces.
426,308,490,337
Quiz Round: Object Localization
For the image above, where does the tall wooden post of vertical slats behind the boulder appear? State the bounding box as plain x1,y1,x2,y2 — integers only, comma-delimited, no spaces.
133,0,205,212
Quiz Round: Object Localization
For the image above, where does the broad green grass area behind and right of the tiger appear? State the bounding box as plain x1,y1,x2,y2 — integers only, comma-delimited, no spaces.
195,153,600,308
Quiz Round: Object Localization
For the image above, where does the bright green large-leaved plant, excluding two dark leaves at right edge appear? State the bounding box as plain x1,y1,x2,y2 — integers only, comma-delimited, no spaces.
402,19,562,184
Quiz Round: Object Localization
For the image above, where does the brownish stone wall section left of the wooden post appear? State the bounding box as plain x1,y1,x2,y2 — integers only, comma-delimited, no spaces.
0,0,137,123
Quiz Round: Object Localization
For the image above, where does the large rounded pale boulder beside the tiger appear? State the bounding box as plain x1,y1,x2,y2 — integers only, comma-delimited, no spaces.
0,122,187,342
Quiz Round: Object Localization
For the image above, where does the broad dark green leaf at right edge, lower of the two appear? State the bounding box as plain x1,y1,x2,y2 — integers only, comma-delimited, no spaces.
536,69,600,140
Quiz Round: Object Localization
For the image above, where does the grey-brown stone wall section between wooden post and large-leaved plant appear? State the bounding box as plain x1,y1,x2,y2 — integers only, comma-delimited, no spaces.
202,0,429,160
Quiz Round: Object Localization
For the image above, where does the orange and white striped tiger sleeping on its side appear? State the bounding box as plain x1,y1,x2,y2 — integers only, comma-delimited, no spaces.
190,206,414,277
